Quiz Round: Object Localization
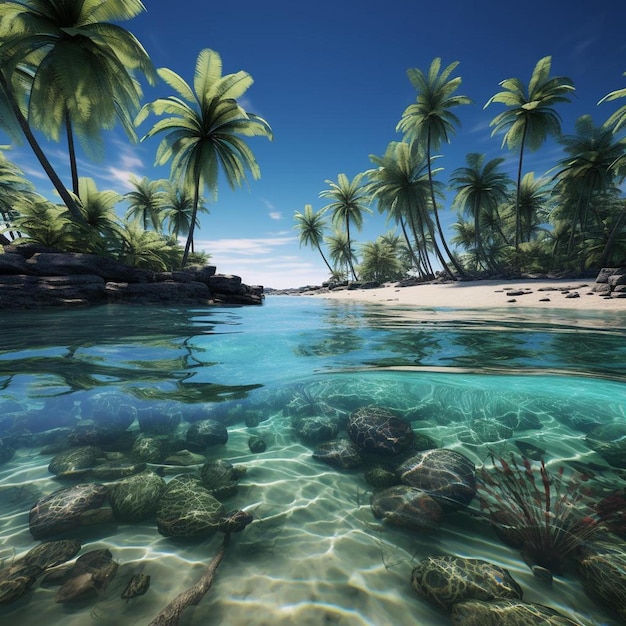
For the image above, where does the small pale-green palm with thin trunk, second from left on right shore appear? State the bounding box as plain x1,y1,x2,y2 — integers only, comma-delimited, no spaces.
320,173,372,280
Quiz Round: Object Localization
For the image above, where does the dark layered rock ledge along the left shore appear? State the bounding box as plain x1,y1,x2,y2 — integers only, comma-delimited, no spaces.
0,244,264,309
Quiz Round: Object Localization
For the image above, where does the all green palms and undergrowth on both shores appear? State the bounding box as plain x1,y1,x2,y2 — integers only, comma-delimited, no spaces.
0,2,626,303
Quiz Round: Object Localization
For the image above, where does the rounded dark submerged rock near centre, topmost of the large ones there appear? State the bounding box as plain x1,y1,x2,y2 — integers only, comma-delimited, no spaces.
348,406,415,455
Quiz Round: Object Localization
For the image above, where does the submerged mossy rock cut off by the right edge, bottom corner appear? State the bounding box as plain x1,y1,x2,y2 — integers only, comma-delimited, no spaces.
576,540,626,622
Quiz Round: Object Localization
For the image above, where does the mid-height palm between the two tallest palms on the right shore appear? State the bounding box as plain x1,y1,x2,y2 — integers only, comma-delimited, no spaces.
450,152,512,267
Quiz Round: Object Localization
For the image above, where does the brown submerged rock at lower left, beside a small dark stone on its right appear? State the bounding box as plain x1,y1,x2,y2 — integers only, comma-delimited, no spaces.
54,549,118,603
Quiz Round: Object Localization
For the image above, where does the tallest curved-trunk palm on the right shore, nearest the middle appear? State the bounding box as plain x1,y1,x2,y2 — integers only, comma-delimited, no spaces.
396,57,471,278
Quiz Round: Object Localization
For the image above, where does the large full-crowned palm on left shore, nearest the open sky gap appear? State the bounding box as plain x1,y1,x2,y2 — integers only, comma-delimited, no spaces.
136,49,272,265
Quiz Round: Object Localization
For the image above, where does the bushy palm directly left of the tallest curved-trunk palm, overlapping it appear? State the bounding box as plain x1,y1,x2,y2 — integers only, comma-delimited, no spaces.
366,141,441,277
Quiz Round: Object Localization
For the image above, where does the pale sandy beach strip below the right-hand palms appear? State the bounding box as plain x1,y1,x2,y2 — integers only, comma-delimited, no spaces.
315,279,626,311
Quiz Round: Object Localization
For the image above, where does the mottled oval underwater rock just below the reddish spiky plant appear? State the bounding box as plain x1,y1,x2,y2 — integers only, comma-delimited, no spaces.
411,556,522,611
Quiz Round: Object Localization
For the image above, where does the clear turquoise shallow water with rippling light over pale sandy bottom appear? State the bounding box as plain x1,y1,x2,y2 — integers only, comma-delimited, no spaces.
0,297,626,626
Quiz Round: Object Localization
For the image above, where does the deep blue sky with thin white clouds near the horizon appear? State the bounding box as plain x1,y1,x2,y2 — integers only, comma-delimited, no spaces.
7,0,626,287
